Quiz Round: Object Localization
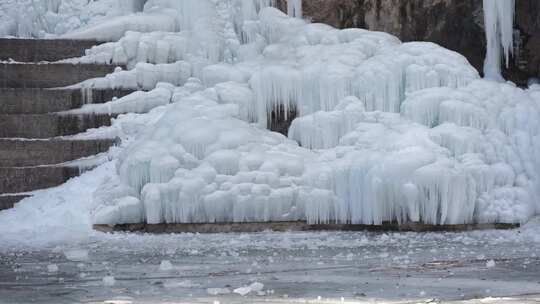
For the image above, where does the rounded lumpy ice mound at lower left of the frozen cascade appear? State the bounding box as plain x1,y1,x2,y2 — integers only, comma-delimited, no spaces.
96,88,313,223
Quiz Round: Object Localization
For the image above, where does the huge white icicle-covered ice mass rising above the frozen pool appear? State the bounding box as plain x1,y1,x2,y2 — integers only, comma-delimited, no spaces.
81,0,540,225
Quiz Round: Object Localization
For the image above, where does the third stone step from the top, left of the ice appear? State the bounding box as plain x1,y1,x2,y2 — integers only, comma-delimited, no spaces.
0,88,133,114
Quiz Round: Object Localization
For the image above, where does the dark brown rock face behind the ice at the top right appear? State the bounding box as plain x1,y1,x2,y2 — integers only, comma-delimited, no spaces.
278,0,540,84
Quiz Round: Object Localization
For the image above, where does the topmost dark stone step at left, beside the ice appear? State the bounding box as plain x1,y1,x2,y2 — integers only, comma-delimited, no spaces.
0,39,99,62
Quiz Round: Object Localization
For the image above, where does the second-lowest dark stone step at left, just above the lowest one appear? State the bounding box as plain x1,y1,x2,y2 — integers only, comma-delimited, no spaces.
0,166,80,194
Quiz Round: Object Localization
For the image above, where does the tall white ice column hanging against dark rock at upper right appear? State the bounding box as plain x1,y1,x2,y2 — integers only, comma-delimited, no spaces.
484,0,515,81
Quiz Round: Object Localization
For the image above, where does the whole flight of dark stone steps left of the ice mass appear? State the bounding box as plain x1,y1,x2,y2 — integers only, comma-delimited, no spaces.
0,39,127,210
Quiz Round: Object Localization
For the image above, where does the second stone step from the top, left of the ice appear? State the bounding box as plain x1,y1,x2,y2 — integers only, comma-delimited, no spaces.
0,63,116,88
